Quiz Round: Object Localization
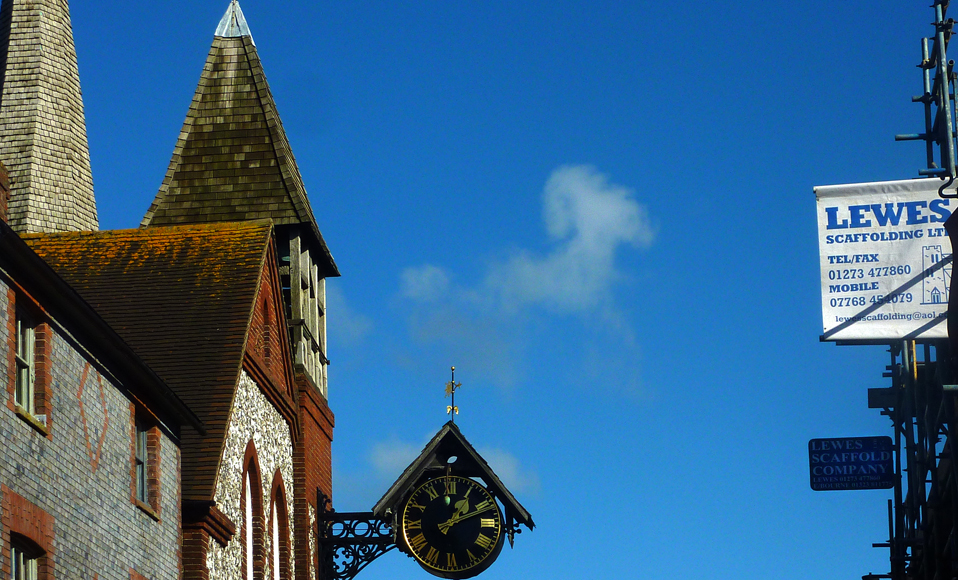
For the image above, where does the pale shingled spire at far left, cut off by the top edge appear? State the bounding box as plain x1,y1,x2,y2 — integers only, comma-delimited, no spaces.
0,0,98,233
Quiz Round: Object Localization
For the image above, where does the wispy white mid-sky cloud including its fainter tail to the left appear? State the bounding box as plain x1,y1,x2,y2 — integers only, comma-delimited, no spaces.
400,165,655,391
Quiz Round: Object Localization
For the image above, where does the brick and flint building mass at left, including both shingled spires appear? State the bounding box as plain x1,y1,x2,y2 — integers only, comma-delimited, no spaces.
0,0,339,580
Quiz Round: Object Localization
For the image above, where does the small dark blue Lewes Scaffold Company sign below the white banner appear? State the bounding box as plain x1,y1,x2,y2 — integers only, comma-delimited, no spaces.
808,437,895,491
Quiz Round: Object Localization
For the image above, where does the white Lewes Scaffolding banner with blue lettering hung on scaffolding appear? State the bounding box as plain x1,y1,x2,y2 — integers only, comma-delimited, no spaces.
815,179,958,342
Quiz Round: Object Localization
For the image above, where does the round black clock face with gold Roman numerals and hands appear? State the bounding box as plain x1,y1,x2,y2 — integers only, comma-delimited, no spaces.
402,475,503,578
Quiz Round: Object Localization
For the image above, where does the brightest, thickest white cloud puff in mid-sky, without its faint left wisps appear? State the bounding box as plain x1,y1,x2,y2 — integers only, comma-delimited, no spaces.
486,165,654,312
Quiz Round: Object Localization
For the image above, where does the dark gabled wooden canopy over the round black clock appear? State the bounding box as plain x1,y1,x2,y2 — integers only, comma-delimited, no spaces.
373,421,535,530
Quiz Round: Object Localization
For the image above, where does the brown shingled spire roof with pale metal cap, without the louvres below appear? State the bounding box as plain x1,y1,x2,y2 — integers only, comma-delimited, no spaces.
141,0,339,276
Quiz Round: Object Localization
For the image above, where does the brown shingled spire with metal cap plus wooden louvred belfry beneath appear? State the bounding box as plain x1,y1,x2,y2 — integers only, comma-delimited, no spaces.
140,0,339,396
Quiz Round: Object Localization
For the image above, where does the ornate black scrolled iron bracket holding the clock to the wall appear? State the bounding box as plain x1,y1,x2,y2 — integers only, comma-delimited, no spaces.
316,491,396,580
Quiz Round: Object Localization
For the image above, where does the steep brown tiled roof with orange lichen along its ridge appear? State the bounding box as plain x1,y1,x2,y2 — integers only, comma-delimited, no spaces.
23,220,272,499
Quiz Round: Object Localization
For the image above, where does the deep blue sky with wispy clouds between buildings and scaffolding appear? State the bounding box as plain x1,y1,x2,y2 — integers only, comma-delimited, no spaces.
71,0,932,580
